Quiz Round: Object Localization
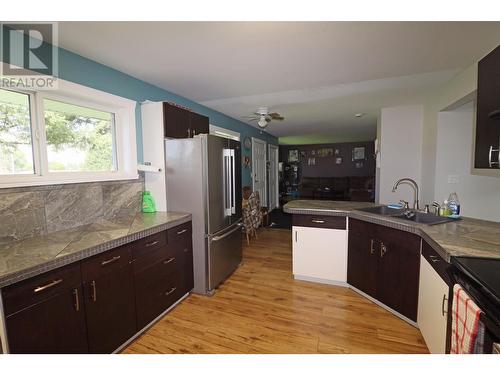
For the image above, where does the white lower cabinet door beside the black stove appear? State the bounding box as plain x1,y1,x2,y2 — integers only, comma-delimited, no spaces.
417,256,449,354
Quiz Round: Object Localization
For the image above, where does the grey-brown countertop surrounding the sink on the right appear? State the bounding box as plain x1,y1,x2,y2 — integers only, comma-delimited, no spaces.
284,200,500,262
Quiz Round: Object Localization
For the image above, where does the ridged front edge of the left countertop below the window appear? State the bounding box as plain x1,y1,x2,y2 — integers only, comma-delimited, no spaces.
0,213,192,288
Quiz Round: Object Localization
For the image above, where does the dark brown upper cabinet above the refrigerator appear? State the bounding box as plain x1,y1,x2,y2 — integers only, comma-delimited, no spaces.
163,103,209,138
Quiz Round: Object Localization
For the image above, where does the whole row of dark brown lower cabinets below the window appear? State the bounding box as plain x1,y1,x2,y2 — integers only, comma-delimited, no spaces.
1,222,193,353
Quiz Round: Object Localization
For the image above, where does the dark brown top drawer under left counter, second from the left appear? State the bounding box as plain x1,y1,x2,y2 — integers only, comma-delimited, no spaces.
82,245,131,281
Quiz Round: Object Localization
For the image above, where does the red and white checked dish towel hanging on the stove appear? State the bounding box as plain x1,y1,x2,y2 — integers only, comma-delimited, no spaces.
450,284,481,354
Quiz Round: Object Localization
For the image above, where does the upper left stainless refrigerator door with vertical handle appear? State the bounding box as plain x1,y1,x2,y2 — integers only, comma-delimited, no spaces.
207,135,231,234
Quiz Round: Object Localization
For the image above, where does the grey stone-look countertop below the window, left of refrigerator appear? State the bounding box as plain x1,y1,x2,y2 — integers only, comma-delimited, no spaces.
0,212,191,288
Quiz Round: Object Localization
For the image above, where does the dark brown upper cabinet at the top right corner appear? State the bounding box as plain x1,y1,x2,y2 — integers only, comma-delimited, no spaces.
474,46,500,169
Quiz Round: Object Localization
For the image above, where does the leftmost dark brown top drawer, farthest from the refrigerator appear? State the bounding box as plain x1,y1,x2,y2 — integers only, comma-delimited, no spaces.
2,263,82,316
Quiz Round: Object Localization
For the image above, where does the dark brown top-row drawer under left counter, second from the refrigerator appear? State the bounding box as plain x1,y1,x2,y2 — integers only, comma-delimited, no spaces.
132,231,173,273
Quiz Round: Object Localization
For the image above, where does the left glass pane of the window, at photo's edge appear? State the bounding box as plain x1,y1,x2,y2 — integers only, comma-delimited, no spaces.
0,89,35,175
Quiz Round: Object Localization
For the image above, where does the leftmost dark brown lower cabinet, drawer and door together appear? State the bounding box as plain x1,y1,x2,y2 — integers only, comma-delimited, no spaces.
2,264,88,354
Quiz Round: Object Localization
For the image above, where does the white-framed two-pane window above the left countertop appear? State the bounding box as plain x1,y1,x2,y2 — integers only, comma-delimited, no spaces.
0,80,138,187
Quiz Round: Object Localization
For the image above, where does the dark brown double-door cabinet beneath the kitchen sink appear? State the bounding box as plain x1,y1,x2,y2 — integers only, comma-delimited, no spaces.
347,219,420,321
